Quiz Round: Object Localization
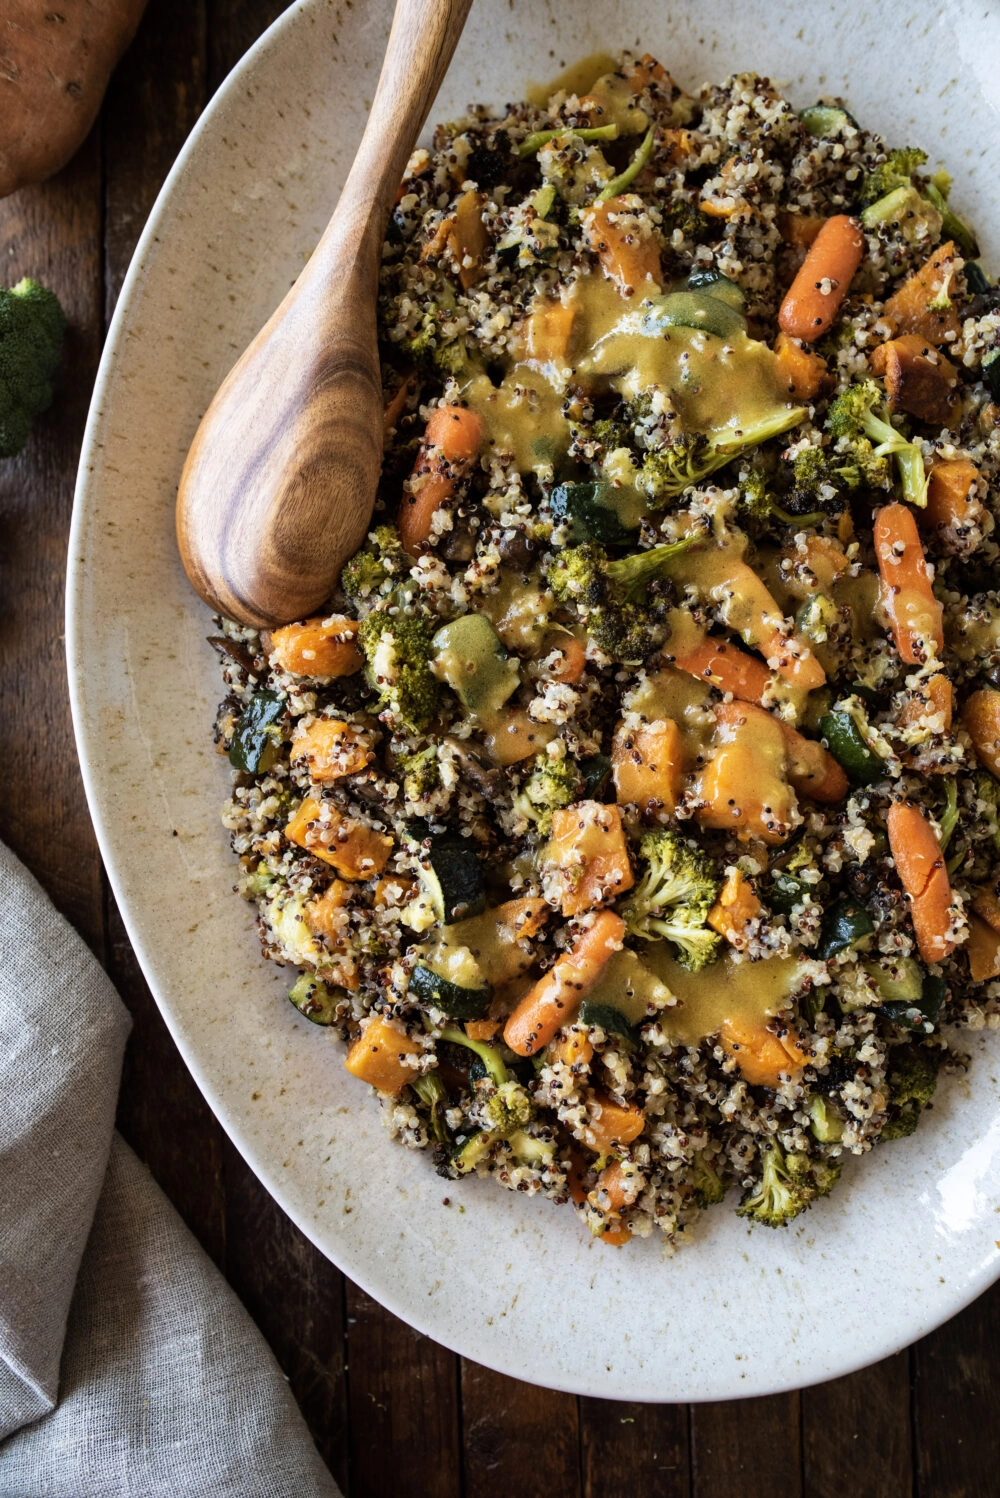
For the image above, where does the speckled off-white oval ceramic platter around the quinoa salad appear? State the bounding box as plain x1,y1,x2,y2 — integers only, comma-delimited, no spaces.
69,0,1000,1401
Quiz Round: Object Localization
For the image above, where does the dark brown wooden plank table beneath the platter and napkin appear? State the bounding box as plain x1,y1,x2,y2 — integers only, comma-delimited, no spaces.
0,0,1000,1498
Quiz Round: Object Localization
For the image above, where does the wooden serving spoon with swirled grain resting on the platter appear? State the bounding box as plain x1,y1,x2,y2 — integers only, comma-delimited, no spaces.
177,0,472,626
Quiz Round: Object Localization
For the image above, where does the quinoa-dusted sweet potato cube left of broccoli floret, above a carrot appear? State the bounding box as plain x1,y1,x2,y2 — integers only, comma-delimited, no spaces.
543,801,635,915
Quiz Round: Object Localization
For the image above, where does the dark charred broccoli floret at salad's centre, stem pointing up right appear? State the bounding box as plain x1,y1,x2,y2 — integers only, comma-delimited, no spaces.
548,532,701,665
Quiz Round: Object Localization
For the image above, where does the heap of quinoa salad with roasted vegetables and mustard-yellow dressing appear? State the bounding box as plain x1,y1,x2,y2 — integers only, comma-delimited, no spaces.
213,52,1000,1246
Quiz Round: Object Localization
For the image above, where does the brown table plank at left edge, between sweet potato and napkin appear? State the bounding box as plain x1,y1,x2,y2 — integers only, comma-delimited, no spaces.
0,146,103,953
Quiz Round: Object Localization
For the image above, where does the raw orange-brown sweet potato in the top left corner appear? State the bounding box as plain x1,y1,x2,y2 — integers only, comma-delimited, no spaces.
0,0,145,198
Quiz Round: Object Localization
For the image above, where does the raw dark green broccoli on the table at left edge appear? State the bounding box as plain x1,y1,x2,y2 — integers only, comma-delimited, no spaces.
0,277,66,458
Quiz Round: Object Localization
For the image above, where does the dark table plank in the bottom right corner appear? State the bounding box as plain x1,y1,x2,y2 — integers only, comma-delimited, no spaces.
913,1276,1000,1498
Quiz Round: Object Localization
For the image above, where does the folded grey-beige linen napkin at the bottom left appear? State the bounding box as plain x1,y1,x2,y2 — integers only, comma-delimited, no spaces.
0,845,338,1498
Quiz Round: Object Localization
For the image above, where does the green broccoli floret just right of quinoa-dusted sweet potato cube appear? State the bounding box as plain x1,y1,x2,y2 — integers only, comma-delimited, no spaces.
621,827,722,972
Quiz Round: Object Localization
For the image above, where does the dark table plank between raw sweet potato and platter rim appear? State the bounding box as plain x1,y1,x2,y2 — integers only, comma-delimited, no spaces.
100,0,205,321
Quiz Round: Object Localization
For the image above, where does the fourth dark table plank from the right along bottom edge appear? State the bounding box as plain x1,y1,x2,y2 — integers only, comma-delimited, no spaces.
579,1399,692,1498
